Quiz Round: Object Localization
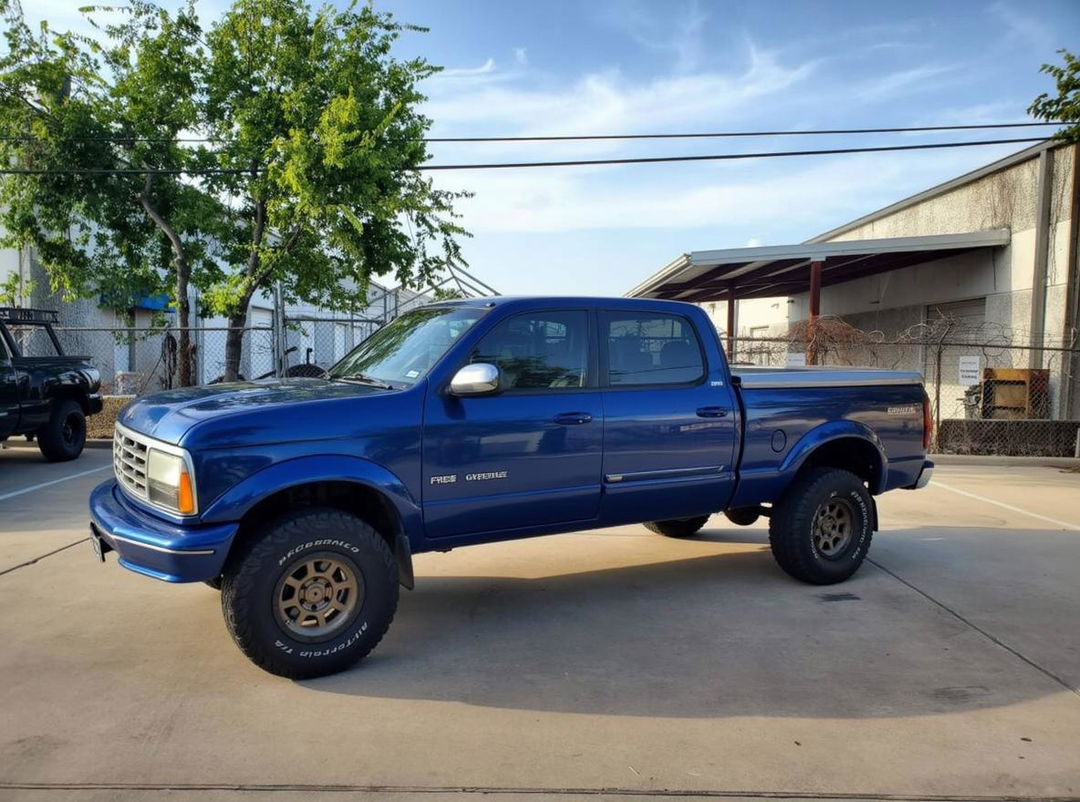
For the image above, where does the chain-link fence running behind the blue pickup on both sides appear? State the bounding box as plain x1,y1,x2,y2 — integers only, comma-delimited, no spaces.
10,310,1080,457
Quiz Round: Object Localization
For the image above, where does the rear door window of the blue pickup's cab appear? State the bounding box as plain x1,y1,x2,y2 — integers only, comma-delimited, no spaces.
600,312,705,386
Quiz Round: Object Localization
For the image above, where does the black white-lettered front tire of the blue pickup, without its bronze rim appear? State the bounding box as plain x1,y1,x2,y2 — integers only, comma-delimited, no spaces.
221,507,397,679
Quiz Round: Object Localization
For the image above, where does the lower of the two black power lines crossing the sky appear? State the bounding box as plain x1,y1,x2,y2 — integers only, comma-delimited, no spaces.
0,137,1049,176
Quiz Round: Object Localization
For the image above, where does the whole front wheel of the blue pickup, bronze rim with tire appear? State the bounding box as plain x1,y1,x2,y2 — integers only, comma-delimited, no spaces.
221,507,397,679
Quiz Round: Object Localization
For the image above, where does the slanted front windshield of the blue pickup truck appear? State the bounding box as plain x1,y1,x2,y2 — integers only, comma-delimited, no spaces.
329,307,487,388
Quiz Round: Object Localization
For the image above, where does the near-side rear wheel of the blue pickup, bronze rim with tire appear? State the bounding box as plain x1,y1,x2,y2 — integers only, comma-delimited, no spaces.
769,467,874,585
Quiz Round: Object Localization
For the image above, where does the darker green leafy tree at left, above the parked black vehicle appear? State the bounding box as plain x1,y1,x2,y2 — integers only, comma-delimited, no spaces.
0,0,221,384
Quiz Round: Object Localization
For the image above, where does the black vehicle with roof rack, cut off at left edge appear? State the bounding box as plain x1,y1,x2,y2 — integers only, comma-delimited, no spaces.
0,308,102,462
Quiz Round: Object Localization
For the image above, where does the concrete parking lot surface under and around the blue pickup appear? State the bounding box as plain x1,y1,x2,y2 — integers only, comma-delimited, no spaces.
0,447,1080,802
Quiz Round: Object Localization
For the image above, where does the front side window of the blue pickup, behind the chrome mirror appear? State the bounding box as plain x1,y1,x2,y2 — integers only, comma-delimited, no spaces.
470,312,589,390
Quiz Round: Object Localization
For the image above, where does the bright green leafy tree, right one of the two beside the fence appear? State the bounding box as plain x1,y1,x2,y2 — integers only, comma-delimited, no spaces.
202,0,464,378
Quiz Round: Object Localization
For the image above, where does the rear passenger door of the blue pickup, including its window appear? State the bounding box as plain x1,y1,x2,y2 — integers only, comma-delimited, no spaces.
599,311,738,524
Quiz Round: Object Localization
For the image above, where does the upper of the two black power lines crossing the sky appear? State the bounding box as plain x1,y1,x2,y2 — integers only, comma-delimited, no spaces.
0,121,1065,145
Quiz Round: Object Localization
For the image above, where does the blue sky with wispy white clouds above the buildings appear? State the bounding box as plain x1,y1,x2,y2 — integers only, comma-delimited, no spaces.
33,0,1080,295
